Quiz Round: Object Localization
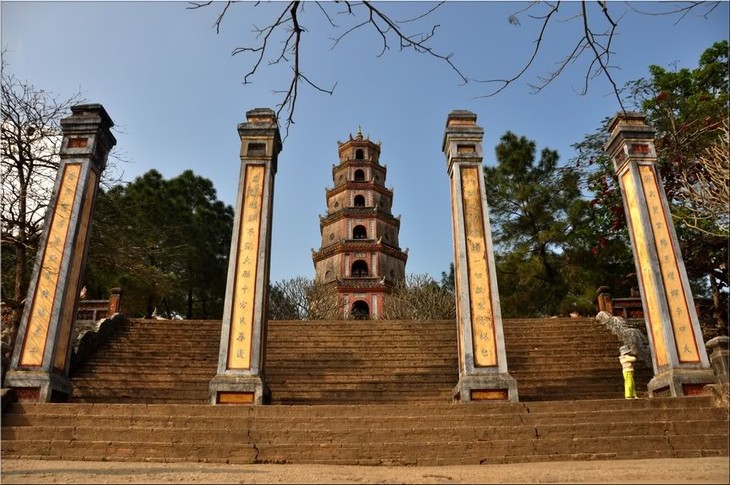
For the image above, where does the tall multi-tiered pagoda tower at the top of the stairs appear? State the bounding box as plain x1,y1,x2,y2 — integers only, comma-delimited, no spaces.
312,128,408,319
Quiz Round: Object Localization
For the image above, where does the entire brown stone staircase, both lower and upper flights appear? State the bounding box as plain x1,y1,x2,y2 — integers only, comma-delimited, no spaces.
2,319,728,465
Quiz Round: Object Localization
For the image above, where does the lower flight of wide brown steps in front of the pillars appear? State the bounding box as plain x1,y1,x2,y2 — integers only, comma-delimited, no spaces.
2,397,728,465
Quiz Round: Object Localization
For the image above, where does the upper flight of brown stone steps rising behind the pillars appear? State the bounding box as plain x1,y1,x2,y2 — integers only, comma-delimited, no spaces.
64,319,652,404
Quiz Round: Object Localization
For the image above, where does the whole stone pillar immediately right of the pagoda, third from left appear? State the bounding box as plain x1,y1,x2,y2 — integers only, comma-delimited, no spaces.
442,110,518,402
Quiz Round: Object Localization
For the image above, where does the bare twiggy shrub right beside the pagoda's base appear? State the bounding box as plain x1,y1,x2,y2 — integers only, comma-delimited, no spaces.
382,274,456,320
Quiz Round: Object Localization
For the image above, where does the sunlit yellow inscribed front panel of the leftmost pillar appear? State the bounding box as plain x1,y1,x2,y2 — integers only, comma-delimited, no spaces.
18,164,81,367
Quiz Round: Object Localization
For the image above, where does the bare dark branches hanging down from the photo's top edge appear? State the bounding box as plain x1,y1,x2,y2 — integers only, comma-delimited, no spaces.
188,0,721,132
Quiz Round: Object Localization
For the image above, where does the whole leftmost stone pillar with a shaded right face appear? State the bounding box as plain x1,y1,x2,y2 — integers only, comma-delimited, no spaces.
5,104,116,402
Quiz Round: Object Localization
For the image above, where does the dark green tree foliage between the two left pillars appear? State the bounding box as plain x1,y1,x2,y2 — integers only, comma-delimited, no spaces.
85,170,233,318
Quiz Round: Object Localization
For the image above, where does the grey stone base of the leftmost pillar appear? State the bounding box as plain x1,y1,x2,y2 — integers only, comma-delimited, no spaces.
5,370,73,402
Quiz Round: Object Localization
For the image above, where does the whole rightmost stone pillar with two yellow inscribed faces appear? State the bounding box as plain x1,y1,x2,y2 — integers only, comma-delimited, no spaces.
606,112,715,397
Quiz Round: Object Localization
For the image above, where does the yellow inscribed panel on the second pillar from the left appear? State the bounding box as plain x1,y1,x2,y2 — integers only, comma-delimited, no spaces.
228,165,266,369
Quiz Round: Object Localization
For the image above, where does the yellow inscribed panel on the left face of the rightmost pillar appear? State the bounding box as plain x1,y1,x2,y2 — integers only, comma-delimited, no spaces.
621,170,669,368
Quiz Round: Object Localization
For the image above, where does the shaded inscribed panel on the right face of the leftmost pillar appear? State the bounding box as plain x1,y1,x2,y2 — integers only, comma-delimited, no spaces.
53,170,99,371
